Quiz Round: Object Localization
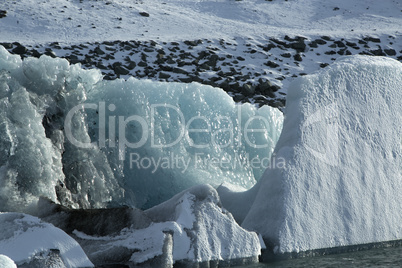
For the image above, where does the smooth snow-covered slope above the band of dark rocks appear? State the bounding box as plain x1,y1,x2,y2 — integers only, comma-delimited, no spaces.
0,0,402,43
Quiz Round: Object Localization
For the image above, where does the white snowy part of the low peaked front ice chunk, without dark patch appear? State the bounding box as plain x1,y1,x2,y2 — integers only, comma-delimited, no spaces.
74,185,261,267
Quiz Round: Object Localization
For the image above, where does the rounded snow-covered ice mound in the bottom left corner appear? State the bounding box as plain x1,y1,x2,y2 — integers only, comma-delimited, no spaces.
0,213,93,267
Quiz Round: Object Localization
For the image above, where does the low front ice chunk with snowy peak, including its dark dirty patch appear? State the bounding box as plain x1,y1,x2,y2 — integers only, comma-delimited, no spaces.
34,185,261,267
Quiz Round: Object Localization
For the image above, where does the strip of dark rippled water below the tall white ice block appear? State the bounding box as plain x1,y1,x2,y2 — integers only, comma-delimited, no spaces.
238,246,402,268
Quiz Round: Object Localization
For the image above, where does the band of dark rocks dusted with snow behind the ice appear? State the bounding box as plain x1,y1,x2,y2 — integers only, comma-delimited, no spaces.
0,36,402,108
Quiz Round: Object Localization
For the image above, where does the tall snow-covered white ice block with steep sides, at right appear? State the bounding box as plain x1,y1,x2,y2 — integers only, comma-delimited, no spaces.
242,56,402,253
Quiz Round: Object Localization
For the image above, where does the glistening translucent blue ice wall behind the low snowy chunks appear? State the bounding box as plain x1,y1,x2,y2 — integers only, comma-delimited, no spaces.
0,47,282,211
